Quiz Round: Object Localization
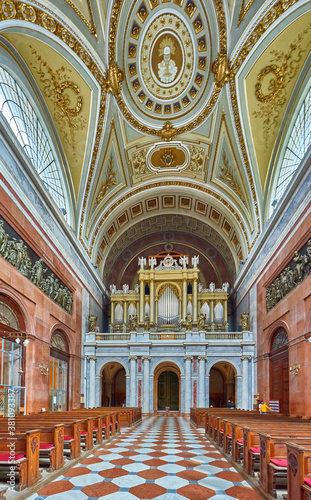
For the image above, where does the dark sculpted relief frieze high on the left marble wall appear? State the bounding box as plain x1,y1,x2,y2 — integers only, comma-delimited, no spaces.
0,219,72,314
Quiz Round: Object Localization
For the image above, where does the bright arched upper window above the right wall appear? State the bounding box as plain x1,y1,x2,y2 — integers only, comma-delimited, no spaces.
272,88,311,211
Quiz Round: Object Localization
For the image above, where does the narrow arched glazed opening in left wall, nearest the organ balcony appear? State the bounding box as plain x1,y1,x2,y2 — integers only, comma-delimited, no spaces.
49,331,69,411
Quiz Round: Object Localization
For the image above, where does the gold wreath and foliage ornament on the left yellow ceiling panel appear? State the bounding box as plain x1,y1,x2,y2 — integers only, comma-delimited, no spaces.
31,49,86,158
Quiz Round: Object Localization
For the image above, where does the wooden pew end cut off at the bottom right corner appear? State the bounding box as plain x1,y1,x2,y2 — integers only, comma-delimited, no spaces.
286,443,311,500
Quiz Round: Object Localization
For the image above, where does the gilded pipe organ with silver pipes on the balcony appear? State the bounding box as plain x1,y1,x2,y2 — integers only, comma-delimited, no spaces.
110,252,229,332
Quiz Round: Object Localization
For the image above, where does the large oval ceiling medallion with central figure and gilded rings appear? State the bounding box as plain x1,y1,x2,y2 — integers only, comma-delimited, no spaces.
117,1,214,122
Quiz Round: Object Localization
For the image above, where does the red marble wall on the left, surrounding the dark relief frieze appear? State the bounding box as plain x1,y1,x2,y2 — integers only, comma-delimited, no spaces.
0,185,82,412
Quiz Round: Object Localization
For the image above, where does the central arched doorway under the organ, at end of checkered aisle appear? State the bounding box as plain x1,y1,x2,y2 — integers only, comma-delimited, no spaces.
154,363,180,411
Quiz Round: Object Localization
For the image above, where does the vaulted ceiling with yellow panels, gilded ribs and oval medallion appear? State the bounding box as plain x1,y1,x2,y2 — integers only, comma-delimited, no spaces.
0,0,311,288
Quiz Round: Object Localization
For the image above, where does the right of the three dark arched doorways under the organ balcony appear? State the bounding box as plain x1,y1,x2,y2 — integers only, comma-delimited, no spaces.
209,361,236,408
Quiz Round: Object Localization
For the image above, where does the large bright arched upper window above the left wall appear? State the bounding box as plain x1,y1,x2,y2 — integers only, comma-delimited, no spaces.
0,67,68,221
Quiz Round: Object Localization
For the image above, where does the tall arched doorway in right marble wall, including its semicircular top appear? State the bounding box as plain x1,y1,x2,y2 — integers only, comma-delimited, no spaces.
270,328,289,413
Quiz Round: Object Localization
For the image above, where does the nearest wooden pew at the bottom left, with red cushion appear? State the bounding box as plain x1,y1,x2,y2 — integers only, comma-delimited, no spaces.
0,429,40,491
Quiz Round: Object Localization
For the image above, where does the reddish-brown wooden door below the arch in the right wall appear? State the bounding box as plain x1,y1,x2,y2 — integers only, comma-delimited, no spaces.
270,348,289,413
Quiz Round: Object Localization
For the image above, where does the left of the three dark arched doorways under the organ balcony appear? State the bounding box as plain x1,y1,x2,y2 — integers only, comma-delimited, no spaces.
102,363,126,406
